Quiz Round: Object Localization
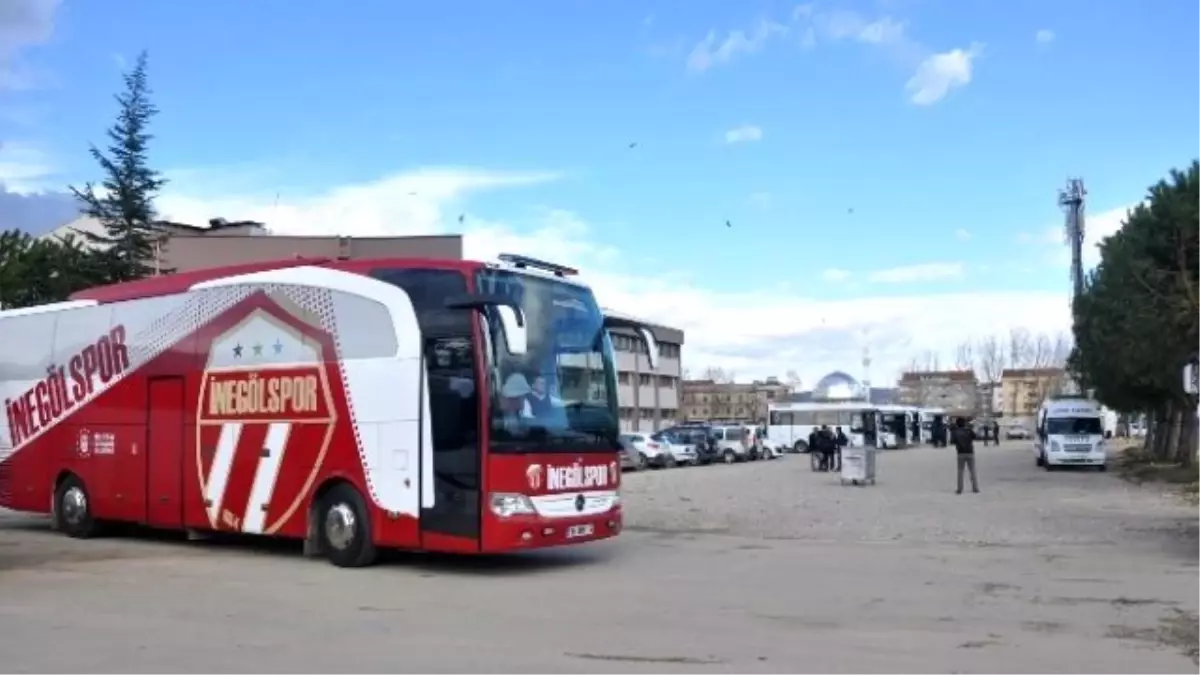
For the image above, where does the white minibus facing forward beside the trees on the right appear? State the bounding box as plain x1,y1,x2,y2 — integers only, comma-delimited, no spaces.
1033,398,1109,471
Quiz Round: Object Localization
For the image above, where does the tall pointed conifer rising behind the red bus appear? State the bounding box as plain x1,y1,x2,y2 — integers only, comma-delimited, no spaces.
71,52,167,277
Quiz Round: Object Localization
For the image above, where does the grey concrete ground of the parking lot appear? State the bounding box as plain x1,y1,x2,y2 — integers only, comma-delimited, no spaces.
0,443,1200,675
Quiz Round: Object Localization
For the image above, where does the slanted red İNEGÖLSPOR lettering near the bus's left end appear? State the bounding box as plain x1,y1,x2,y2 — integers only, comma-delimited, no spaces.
4,325,130,448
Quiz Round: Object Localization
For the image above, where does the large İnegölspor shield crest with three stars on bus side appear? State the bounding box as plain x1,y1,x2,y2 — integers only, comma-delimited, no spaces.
196,302,336,534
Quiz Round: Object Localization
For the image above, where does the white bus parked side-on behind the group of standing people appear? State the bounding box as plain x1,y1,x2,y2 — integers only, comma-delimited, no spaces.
767,401,882,453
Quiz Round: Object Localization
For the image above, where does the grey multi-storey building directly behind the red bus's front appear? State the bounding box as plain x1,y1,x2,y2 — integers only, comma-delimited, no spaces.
605,309,683,431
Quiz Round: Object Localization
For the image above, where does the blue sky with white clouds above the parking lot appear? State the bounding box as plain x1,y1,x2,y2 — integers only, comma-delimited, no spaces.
0,0,1200,380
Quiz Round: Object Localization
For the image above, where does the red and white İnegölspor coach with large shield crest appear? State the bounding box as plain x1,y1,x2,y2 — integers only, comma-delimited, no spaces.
0,255,658,567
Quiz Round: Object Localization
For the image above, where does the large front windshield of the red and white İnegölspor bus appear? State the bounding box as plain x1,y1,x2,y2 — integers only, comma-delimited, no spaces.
476,269,619,453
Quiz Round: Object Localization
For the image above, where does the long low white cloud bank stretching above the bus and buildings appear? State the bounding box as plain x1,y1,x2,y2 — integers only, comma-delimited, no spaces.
158,168,1069,384
